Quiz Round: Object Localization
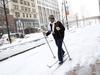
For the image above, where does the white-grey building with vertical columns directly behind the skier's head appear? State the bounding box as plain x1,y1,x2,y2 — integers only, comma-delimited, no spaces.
37,0,60,28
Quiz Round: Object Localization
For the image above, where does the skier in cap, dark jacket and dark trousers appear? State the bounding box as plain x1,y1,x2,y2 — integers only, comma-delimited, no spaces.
45,15,65,64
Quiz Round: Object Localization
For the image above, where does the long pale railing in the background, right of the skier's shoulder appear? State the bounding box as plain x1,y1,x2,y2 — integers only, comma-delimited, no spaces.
65,16,100,28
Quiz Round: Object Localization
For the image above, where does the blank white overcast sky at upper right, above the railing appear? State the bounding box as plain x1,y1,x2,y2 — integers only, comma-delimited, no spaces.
58,0,99,17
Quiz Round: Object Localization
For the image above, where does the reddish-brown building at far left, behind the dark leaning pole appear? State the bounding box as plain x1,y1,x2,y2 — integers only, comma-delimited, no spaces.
0,0,15,33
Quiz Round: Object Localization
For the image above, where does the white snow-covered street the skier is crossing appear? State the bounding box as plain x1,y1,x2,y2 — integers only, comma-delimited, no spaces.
0,24,100,75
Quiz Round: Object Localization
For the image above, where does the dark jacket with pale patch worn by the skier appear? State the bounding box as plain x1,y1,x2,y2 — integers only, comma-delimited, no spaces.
46,21,65,40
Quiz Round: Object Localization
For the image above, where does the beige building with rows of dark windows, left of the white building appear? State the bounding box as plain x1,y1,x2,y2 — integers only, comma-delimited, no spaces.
8,0,39,32
